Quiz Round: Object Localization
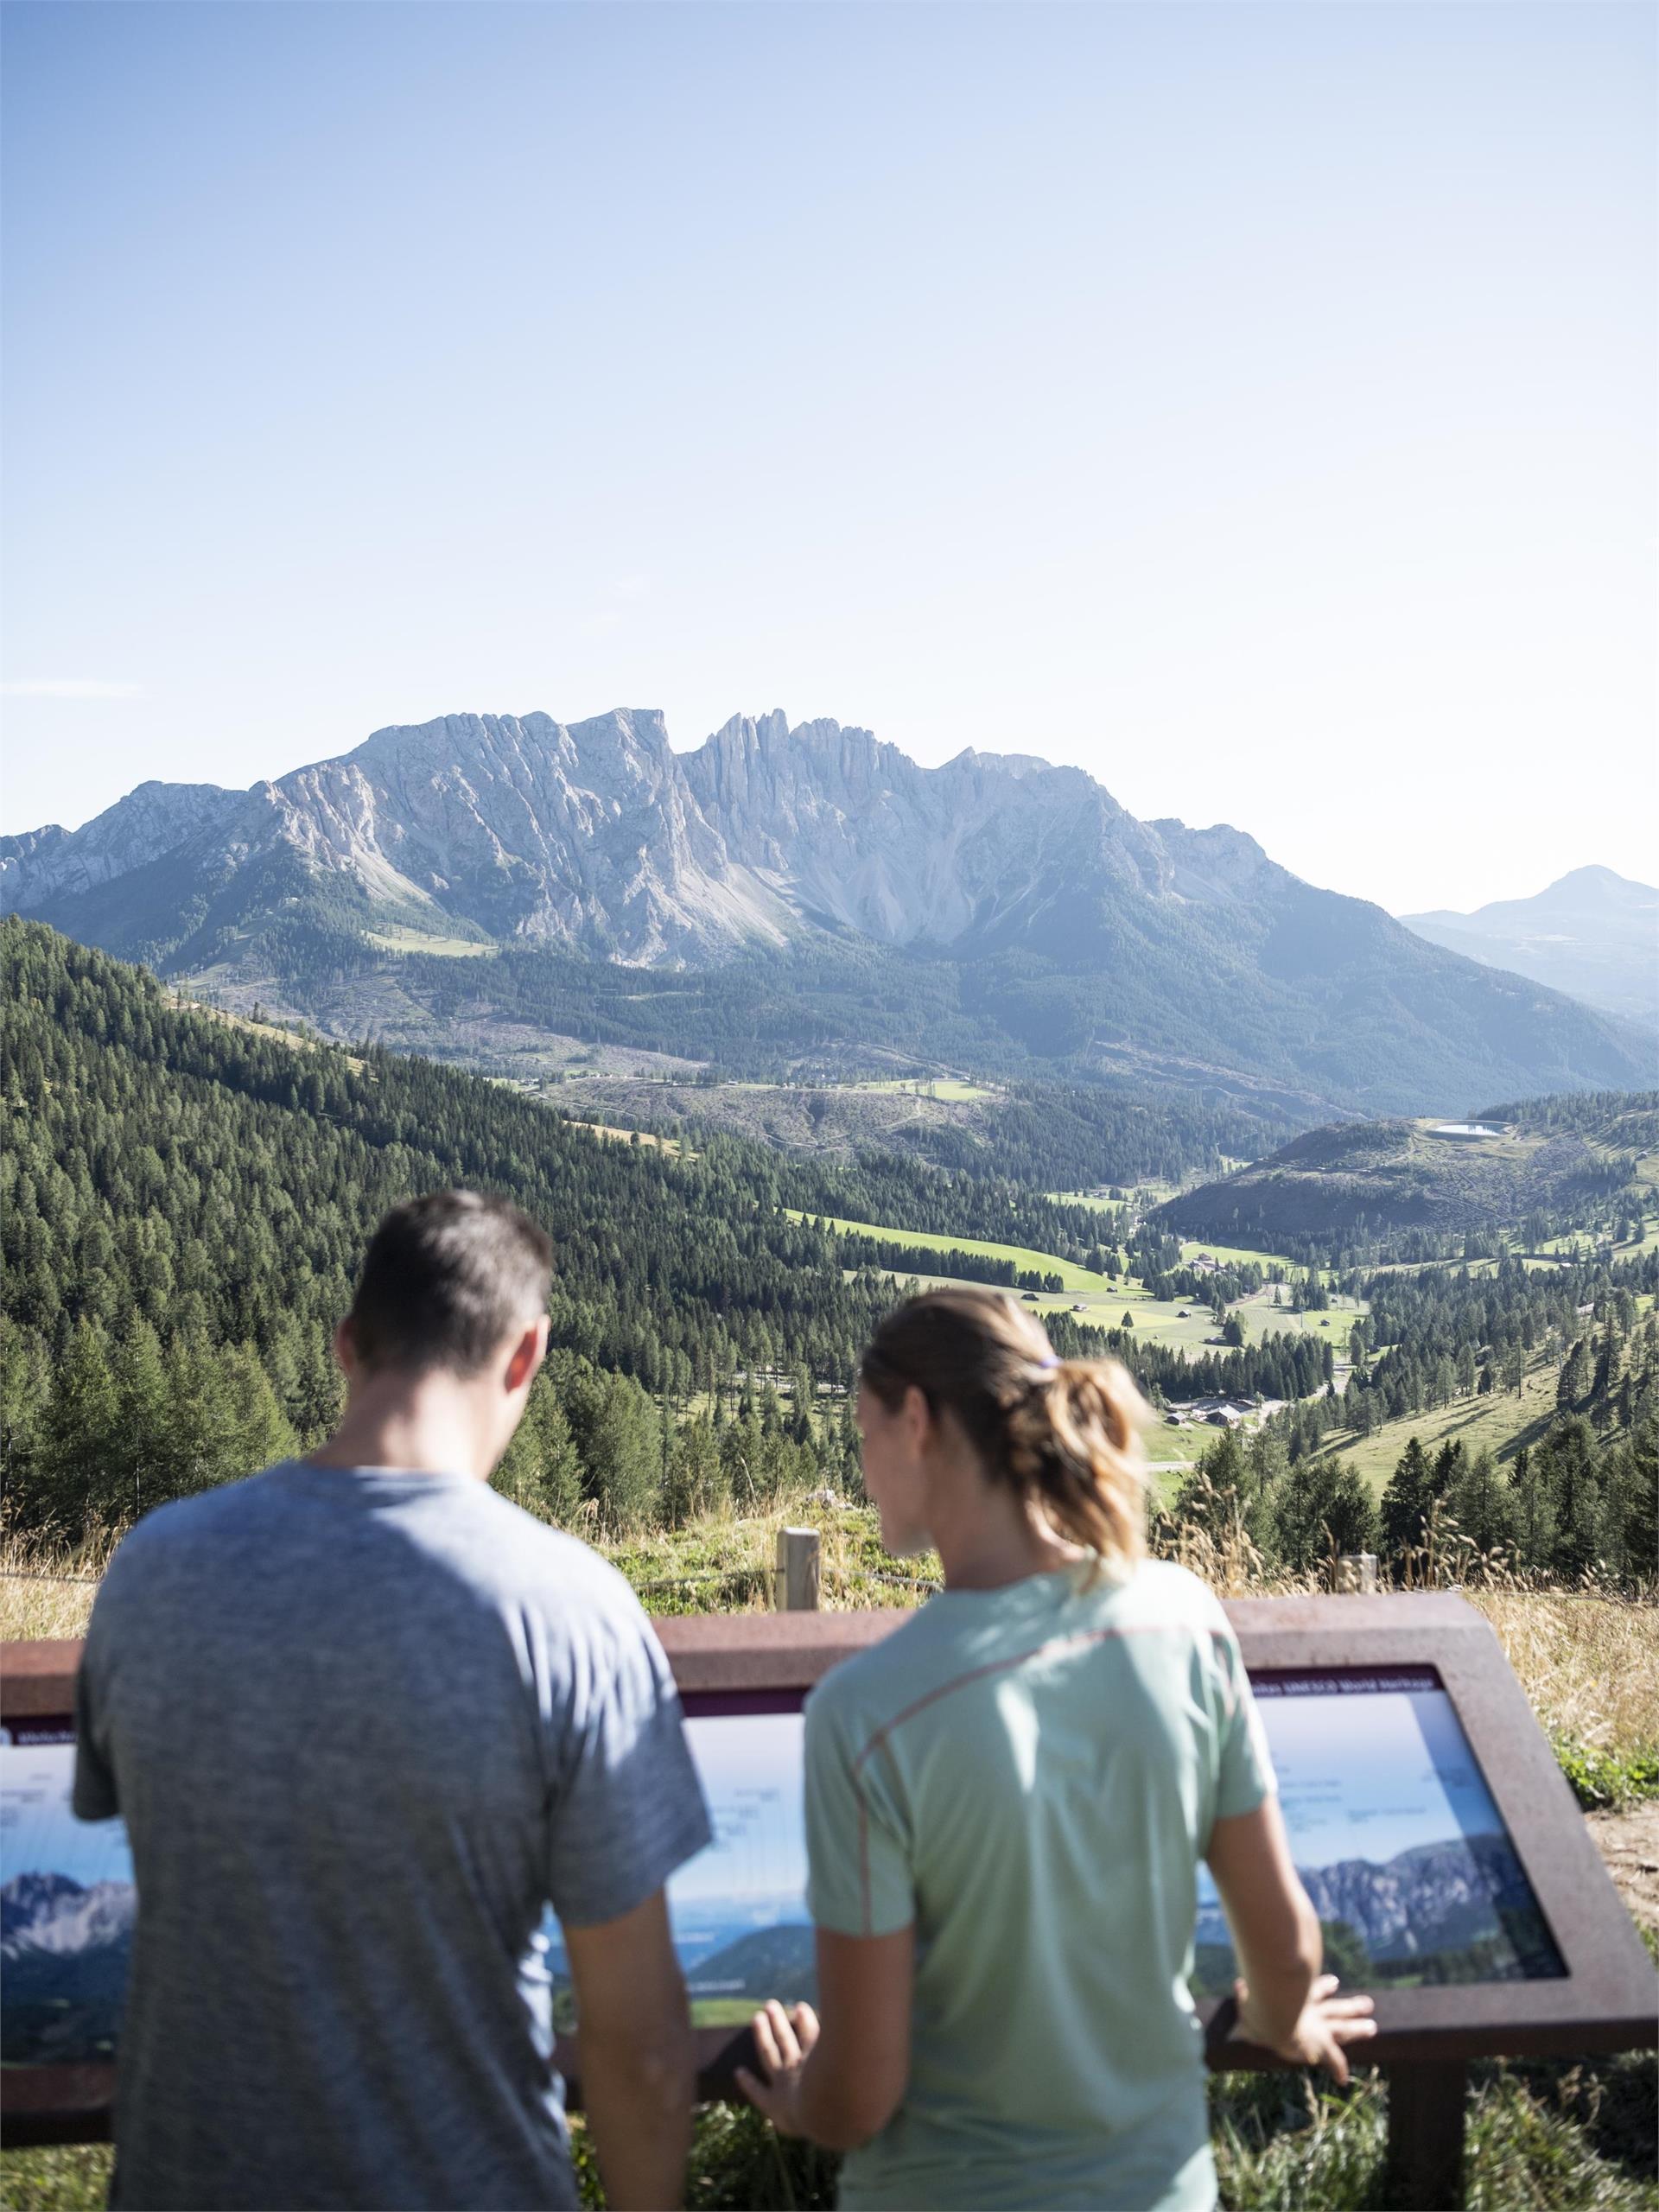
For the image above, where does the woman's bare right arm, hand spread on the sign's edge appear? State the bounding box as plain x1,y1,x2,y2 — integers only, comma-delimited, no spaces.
1205,1796,1376,2082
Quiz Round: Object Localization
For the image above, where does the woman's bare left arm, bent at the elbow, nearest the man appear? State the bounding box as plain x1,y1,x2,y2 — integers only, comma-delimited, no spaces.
736,1929,916,2150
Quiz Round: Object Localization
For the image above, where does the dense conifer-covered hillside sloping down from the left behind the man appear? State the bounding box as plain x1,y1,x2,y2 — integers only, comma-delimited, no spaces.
0,920,911,1524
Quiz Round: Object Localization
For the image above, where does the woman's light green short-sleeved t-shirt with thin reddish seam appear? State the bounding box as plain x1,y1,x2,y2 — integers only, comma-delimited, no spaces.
805,1561,1272,2212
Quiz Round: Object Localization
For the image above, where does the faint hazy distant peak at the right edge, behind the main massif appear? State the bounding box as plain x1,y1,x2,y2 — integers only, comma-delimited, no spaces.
1400,868,1659,1028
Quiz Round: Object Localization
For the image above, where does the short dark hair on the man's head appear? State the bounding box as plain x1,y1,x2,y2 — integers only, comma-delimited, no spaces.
347,1190,553,1376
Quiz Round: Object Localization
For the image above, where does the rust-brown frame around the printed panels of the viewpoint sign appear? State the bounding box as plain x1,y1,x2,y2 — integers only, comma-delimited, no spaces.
0,1592,1659,2144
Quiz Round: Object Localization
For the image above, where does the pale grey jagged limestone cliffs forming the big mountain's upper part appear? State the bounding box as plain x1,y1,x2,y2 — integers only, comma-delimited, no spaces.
0,710,1269,964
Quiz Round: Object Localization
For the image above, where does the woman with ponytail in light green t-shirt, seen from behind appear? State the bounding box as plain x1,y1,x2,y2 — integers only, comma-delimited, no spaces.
741,1289,1374,2212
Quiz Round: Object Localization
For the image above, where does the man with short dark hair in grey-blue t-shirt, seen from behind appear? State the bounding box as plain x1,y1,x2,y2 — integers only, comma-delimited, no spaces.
75,1190,708,2212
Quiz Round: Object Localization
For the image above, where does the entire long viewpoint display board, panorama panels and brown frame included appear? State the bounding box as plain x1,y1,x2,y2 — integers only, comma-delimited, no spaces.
0,1595,1655,2167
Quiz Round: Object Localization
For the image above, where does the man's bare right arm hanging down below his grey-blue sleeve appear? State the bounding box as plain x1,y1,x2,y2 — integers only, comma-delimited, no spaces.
564,1889,696,2212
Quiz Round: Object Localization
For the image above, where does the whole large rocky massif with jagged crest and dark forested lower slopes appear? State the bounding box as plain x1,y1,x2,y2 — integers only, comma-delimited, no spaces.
0,710,1650,1126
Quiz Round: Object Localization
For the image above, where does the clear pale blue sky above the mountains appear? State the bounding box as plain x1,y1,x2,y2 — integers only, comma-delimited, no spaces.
0,0,1659,912
